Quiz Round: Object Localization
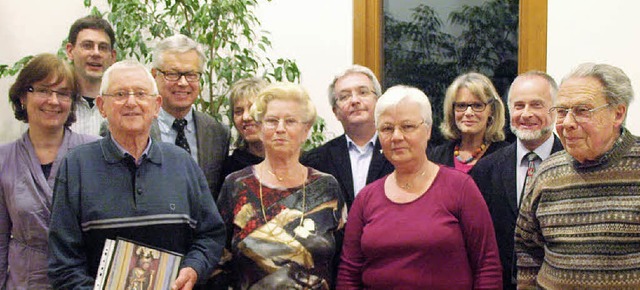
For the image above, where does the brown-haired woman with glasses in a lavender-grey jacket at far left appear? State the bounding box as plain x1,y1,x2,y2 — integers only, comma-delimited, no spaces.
0,54,97,289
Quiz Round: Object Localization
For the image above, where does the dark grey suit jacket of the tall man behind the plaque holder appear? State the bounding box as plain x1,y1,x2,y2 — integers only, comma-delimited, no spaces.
150,110,231,200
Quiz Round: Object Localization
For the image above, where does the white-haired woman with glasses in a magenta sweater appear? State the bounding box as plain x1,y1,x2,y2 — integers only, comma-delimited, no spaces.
337,86,502,289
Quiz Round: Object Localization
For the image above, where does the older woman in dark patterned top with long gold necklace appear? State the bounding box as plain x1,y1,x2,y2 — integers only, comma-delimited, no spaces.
217,83,346,289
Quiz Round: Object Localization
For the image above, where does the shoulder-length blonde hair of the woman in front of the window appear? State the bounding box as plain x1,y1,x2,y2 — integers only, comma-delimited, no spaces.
440,72,505,142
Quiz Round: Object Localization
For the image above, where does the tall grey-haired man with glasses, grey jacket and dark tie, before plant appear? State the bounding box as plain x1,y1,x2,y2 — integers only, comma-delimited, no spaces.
151,34,230,200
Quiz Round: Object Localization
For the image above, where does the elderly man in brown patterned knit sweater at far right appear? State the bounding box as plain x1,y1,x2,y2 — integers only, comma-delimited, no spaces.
515,63,640,289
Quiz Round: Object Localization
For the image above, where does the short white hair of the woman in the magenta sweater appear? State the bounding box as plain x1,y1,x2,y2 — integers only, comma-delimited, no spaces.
374,85,433,127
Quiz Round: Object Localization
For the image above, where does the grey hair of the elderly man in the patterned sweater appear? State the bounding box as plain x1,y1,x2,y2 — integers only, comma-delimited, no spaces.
561,63,633,107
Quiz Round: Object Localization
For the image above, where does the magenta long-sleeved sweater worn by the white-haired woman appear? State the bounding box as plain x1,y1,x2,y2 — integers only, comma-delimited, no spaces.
337,166,502,289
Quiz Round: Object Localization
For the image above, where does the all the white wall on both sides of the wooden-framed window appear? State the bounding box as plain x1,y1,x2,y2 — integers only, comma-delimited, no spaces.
0,0,640,143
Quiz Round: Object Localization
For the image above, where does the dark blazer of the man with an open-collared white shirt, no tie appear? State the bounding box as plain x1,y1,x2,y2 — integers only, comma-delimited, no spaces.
300,134,394,208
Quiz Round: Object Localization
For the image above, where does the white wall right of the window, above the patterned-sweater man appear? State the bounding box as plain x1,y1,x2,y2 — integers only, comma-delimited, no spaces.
547,0,640,135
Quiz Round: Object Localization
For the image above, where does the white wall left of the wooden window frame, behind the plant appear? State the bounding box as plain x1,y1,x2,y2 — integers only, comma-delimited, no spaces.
0,0,353,144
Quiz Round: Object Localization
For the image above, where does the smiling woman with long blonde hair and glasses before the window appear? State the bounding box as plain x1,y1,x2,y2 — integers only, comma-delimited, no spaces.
427,72,509,173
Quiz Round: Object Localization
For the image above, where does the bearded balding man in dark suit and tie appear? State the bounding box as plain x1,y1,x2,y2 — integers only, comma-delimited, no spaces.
469,71,562,289
